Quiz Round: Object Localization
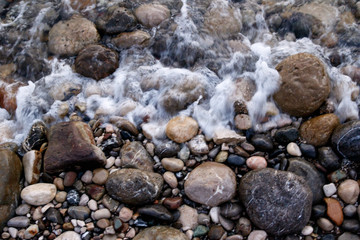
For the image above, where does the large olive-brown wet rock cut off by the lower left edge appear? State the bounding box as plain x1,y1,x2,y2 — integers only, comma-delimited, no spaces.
0,149,22,229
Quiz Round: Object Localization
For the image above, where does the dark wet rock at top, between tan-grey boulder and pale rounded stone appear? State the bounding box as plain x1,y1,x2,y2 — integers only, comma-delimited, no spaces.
96,5,136,34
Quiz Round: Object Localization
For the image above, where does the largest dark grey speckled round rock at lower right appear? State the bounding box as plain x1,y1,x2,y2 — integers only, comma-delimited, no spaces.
239,168,313,236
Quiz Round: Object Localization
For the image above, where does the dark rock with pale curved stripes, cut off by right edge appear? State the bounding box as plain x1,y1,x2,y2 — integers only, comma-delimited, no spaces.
331,120,360,161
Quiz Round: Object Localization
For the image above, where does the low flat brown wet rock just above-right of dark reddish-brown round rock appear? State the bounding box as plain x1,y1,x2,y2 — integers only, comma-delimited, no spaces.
112,30,151,48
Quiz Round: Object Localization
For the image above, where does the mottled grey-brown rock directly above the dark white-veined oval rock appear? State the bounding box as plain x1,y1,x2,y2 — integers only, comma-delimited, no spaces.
120,142,154,172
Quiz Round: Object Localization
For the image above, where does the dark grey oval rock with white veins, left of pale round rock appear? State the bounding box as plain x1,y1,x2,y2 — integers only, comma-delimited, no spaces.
106,168,164,205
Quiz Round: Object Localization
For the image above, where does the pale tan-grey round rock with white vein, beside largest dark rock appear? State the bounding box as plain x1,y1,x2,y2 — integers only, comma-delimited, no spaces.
184,162,236,207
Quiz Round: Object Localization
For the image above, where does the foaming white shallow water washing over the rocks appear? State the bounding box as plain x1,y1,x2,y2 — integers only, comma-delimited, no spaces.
0,0,360,143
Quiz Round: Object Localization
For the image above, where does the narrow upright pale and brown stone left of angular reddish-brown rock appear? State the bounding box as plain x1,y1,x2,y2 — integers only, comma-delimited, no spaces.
22,150,42,184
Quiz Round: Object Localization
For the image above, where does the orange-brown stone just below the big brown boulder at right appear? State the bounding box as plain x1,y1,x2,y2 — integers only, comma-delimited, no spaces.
300,113,340,147
